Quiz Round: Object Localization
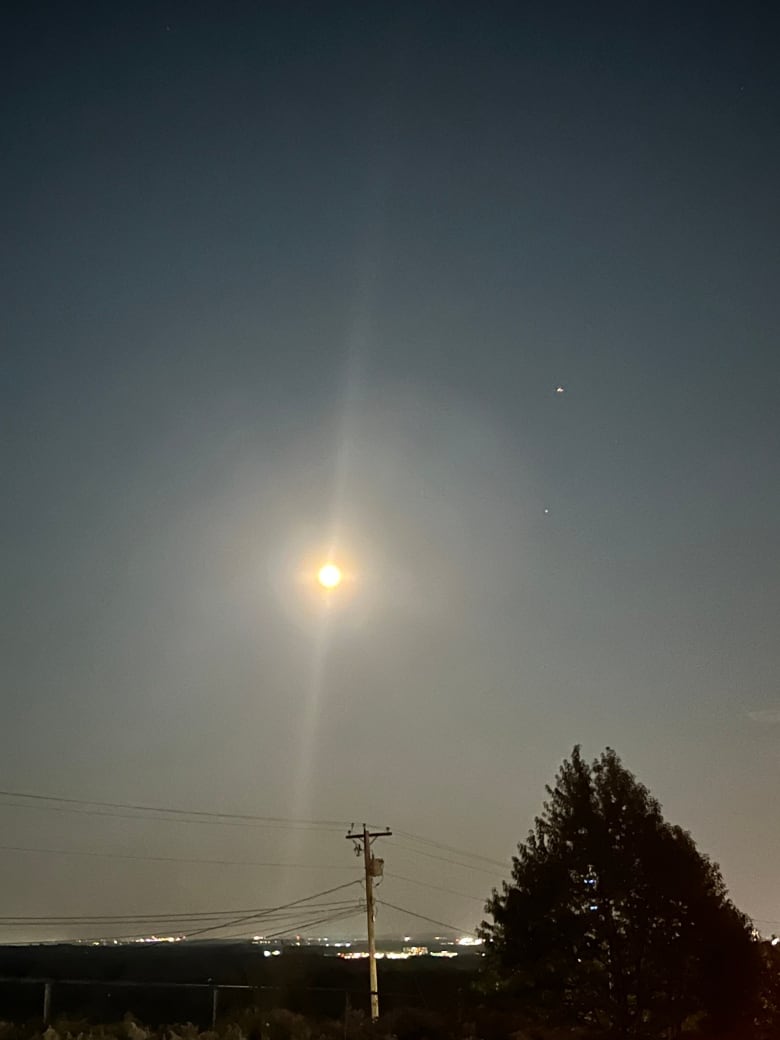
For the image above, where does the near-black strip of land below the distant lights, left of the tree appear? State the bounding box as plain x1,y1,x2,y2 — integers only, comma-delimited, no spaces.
0,942,480,1023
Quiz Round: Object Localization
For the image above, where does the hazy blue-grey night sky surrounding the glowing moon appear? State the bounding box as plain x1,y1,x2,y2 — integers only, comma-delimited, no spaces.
0,0,780,939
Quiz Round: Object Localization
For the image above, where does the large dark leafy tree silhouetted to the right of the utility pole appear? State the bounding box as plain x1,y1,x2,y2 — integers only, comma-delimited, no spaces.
482,747,759,1037
